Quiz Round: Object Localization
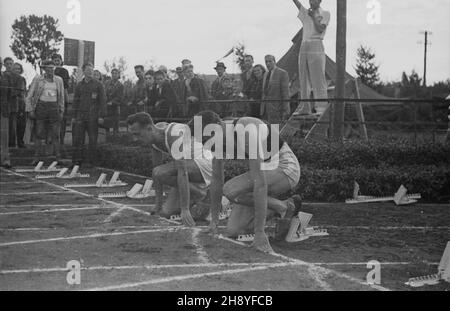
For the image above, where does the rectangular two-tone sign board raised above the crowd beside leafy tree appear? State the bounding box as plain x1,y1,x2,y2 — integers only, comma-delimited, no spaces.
64,38,95,66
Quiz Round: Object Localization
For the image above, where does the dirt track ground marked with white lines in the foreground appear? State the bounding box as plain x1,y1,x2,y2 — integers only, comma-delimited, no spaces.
0,168,450,291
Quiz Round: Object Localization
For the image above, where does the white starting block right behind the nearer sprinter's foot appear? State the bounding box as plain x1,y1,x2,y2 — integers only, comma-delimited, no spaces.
285,212,329,243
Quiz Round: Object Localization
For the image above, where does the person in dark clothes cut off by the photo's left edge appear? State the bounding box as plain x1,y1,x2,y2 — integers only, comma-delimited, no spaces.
0,58,12,169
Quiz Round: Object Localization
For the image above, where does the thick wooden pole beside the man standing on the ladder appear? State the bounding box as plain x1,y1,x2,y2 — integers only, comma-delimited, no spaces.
331,0,347,141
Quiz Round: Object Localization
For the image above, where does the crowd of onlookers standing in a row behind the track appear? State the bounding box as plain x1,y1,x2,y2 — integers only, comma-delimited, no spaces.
0,54,290,167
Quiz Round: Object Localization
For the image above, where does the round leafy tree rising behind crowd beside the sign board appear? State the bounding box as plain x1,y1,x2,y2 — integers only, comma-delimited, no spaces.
10,14,63,69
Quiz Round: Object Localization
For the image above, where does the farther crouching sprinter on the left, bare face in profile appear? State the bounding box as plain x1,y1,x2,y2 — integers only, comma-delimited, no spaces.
127,112,212,226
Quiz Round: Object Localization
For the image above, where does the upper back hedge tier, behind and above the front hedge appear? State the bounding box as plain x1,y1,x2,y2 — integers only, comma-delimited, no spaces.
108,134,450,169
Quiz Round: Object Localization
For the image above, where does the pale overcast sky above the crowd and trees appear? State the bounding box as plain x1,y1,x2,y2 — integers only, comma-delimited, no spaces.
0,0,450,83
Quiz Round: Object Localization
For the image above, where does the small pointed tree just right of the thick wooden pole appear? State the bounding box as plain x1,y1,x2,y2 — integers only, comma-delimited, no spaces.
355,45,380,88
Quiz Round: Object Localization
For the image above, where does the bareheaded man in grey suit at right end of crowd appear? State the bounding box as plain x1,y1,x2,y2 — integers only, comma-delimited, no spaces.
261,55,290,123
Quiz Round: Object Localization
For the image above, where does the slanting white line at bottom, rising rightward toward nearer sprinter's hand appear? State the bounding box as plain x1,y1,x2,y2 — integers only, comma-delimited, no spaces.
86,263,298,291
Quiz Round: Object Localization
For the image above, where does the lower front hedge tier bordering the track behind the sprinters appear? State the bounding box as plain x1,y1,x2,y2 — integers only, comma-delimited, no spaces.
97,144,450,202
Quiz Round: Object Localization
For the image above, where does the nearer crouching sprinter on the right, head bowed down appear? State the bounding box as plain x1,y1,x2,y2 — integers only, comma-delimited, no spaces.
189,111,301,252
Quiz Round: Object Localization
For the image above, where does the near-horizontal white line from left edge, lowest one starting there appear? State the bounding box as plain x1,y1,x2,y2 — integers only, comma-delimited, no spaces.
0,262,274,274
